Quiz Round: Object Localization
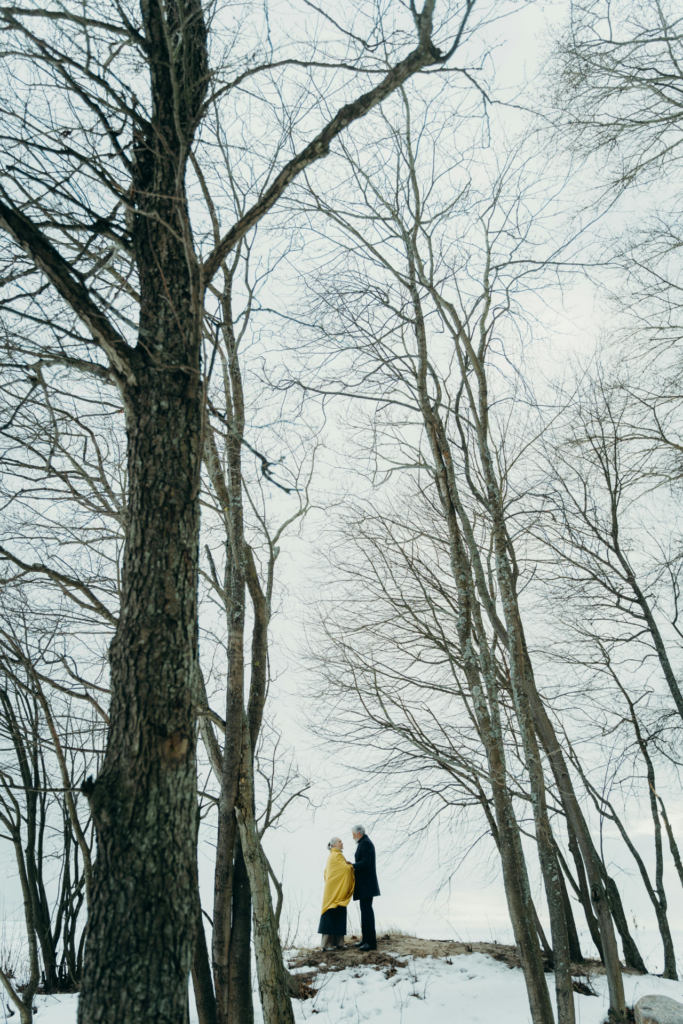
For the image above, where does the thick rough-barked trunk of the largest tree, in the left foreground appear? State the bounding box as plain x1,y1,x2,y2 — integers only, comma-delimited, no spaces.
79,0,208,1024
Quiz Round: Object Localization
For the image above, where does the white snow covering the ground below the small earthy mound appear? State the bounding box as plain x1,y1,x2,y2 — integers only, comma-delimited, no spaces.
29,953,683,1024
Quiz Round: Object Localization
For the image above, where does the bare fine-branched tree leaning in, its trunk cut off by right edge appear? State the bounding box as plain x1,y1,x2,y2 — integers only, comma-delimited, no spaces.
539,372,683,717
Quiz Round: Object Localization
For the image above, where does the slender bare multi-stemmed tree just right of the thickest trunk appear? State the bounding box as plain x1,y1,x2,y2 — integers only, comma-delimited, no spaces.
196,244,314,1024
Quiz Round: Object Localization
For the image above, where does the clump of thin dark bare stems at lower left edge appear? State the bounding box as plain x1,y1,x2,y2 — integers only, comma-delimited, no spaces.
0,592,97,1021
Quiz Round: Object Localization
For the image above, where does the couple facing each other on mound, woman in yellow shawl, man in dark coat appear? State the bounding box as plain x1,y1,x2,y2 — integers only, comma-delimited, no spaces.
317,825,380,952
